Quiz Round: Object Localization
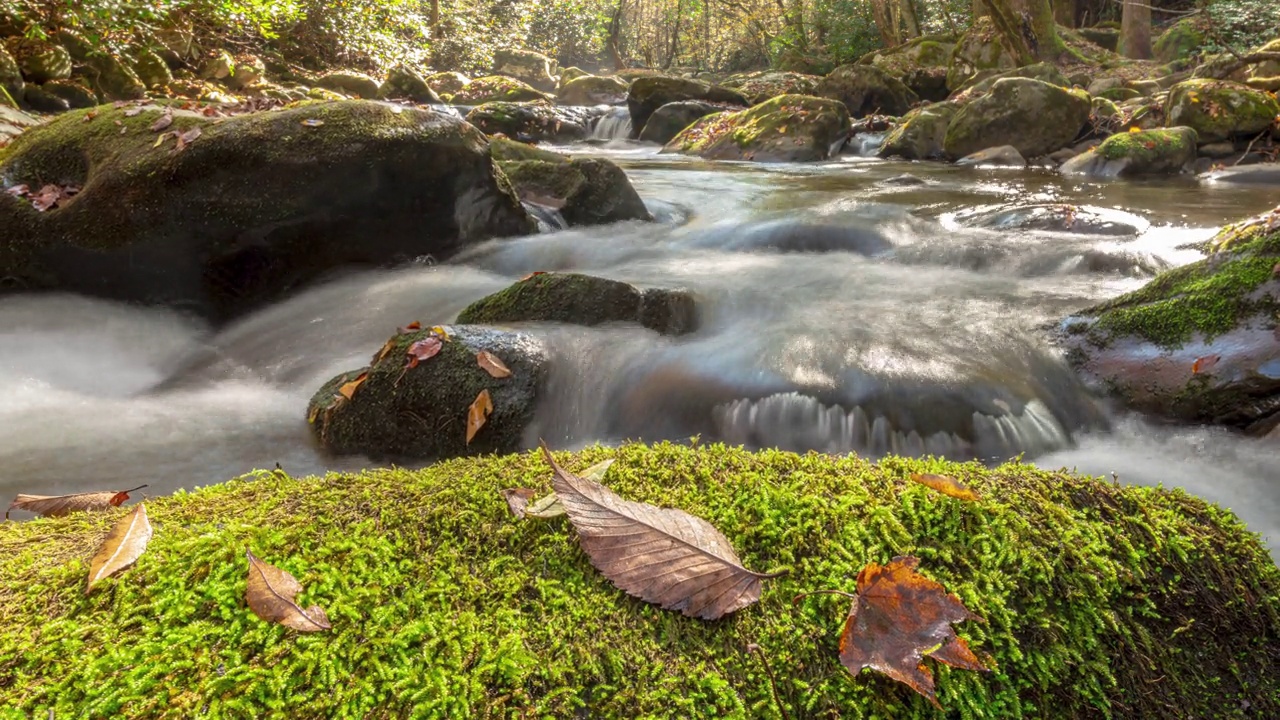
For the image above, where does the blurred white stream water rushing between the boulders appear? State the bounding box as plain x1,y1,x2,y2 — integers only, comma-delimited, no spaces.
0,133,1280,556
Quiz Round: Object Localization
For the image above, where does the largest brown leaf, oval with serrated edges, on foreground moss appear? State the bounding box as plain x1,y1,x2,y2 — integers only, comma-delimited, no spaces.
543,443,776,620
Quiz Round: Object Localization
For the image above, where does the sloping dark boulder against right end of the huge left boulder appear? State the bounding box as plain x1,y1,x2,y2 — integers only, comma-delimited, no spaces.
490,138,653,225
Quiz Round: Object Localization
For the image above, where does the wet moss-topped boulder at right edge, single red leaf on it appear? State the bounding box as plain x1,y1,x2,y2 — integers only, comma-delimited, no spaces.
1062,208,1280,434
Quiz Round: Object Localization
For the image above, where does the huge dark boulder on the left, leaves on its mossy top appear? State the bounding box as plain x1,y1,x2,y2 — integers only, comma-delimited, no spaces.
0,101,534,322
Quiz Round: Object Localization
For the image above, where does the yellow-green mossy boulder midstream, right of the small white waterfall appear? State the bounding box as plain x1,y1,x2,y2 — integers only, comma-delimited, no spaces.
663,95,850,163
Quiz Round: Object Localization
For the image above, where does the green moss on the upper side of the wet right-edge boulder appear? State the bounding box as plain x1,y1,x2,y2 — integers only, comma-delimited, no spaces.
1083,219,1280,348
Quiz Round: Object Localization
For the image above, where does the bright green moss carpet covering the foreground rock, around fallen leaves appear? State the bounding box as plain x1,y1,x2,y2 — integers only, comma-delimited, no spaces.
0,445,1280,720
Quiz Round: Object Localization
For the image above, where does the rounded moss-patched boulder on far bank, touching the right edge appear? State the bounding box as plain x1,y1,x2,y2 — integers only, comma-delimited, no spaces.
1165,79,1280,142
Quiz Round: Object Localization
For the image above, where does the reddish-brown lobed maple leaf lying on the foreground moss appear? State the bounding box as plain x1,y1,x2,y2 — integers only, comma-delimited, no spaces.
840,555,987,708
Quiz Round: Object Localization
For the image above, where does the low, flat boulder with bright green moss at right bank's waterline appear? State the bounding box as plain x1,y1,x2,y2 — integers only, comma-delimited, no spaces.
1061,127,1196,177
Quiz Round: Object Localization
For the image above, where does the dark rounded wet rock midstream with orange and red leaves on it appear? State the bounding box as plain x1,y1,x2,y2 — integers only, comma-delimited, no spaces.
307,325,550,460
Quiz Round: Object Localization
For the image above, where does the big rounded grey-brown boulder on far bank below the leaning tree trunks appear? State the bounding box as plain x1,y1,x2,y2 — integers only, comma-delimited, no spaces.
943,78,1092,158
